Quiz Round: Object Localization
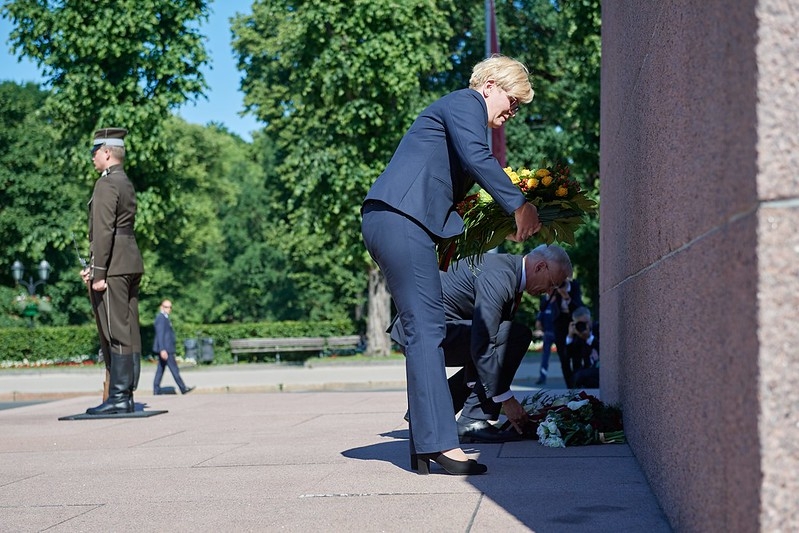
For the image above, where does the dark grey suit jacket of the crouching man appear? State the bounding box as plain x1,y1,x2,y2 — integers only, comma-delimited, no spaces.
391,254,523,398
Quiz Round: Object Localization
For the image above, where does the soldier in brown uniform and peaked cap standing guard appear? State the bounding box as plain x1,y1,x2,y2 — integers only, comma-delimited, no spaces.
81,128,144,415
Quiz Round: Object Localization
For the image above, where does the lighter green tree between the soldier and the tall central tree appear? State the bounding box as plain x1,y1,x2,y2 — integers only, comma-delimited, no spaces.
138,117,270,322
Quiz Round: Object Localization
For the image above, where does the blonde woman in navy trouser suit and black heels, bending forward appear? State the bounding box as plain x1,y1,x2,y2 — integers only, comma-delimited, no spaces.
361,56,541,475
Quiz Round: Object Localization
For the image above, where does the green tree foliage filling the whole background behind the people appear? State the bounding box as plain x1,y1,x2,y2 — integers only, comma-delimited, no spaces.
0,0,600,334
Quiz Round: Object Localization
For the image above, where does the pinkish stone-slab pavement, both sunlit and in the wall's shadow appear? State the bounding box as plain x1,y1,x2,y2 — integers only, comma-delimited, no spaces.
0,357,670,533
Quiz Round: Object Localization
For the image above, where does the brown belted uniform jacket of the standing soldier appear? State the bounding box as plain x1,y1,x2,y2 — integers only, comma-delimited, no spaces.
89,165,144,280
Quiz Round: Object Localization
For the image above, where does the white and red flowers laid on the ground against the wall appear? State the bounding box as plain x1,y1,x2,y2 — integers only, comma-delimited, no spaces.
502,391,626,448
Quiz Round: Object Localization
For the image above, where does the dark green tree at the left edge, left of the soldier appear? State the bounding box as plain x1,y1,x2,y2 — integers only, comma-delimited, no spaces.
0,82,91,324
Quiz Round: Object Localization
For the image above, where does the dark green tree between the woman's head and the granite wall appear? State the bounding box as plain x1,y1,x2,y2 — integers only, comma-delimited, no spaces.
447,0,601,311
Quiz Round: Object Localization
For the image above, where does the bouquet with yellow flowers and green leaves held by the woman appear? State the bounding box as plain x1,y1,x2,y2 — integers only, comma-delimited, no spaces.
438,163,597,270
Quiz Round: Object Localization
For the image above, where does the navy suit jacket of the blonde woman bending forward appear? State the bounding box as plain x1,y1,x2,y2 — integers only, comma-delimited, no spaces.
364,89,525,237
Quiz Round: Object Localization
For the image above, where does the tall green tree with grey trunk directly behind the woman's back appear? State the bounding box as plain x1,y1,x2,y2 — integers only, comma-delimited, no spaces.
233,0,453,354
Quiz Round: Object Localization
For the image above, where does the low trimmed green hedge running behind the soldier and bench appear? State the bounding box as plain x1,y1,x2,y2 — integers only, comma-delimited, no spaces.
0,320,355,364
